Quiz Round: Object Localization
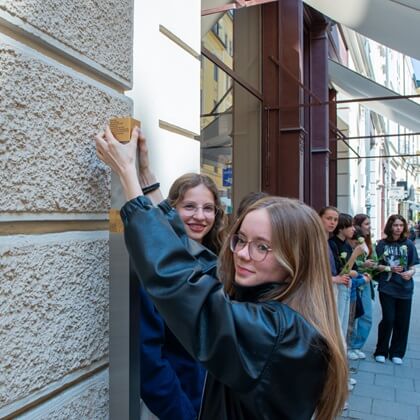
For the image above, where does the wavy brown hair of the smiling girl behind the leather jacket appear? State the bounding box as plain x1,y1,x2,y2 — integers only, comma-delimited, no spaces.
168,173,226,254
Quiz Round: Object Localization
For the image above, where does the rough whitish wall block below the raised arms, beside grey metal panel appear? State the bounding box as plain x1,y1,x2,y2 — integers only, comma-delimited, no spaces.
0,232,109,408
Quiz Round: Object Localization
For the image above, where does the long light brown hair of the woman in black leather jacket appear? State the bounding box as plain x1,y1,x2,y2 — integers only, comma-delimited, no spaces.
219,197,348,420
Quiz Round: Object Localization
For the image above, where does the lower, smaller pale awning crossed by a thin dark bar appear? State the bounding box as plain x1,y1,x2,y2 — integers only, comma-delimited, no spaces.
328,60,420,132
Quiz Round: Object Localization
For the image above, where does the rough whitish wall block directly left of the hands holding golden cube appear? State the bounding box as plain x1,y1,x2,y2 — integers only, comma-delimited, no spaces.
0,35,132,213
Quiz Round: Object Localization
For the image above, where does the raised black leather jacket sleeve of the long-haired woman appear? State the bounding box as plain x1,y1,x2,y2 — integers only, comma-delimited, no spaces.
121,196,293,391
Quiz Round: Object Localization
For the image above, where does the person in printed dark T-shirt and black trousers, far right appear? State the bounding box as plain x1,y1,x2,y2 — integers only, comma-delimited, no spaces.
374,214,419,365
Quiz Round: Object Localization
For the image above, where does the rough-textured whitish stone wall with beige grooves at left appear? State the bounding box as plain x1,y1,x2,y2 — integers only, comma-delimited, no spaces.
0,0,133,419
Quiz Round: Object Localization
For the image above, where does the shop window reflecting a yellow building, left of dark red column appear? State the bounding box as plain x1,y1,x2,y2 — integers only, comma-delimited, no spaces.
200,7,261,214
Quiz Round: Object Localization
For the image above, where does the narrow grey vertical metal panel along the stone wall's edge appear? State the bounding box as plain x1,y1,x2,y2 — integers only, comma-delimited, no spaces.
109,172,140,420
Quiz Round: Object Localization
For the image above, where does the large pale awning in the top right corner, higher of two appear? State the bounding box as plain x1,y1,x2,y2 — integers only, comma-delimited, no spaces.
304,0,420,60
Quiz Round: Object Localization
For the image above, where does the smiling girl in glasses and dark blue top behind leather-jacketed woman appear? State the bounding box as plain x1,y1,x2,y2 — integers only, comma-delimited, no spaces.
124,130,225,420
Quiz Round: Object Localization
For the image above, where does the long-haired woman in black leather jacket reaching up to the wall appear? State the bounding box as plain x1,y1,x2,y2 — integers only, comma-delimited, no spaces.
96,129,347,420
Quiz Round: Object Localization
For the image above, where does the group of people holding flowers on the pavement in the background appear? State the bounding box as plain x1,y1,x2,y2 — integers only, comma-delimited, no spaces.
319,207,419,370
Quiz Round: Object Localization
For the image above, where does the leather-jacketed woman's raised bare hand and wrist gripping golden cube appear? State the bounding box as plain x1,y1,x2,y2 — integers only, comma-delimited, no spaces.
95,126,143,200
